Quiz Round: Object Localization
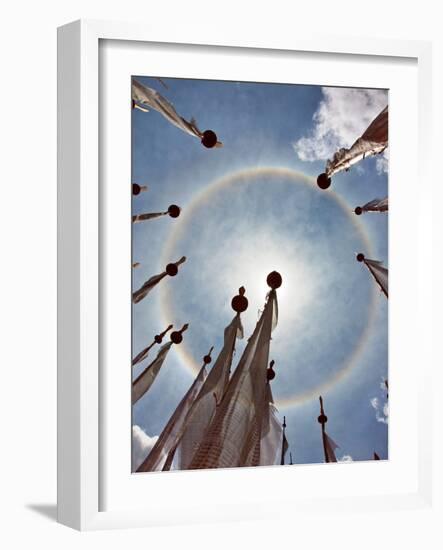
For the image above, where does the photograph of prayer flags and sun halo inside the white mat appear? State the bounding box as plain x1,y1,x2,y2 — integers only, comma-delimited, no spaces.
131,75,389,473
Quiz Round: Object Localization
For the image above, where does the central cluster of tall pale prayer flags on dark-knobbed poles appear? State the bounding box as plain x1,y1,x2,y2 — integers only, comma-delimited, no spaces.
137,272,292,472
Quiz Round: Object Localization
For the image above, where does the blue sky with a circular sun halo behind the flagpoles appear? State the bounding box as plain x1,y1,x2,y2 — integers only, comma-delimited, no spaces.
132,77,388,463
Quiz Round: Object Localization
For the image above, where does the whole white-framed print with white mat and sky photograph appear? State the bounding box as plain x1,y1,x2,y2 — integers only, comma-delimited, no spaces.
58,21,431,529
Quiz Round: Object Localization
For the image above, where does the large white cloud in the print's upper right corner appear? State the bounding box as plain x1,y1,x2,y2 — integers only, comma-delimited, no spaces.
293,88,388,164
